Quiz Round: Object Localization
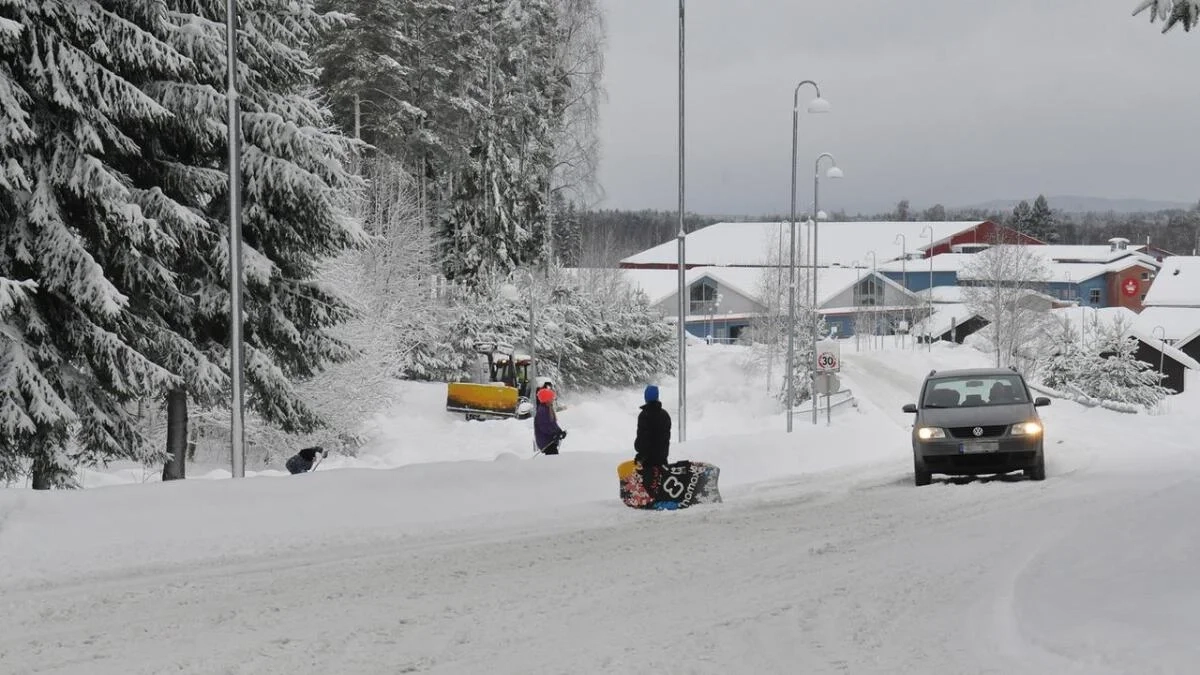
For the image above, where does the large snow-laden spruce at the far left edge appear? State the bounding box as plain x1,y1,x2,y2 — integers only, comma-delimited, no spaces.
0,0,207,489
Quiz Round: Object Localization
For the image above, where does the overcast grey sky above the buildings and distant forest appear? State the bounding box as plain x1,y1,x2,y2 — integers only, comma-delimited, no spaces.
600,0,1200,215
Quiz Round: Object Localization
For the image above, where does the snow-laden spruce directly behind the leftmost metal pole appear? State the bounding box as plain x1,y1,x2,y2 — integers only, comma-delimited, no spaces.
145,0,366,473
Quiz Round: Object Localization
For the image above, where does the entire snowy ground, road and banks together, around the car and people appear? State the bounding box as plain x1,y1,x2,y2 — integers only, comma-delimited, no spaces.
0,341,1200,674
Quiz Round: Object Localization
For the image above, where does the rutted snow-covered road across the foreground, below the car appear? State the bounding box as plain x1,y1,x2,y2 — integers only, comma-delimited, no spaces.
0,454,1200,674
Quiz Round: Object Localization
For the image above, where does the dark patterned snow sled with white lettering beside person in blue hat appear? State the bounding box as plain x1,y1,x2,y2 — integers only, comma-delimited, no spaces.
617,460,721,510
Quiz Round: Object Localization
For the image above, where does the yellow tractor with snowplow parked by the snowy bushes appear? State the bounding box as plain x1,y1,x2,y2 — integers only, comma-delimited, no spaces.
446,341,550,420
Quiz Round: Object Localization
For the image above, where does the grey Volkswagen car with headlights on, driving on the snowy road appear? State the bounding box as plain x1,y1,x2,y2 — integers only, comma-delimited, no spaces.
904,368,1050,485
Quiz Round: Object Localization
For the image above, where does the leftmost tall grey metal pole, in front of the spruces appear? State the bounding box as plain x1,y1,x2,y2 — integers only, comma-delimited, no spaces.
226,0,246,478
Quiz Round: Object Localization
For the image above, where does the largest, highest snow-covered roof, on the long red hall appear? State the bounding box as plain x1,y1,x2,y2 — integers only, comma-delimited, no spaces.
622,221,984,265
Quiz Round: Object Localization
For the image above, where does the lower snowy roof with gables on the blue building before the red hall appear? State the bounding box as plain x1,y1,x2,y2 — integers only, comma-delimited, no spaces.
620,267,911,305
